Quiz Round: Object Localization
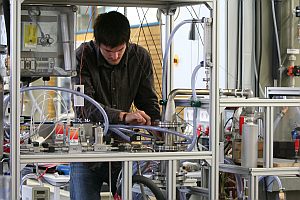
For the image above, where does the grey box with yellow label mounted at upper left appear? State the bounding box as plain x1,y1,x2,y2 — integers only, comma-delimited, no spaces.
21,5,77,77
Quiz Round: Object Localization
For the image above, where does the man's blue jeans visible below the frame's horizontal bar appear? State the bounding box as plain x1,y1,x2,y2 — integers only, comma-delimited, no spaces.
70,162,121,200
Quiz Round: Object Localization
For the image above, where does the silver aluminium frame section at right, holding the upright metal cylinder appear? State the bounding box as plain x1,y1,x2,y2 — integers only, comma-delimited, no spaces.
220,98,300,199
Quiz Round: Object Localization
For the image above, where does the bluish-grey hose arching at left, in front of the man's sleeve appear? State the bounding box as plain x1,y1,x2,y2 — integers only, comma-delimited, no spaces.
3,86,109,135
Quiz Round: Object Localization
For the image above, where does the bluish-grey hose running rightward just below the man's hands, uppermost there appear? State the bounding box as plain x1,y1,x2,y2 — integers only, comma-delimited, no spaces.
109,124,192,144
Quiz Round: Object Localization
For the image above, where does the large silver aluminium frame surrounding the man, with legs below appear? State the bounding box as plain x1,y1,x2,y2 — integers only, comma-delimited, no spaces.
10,0,220,200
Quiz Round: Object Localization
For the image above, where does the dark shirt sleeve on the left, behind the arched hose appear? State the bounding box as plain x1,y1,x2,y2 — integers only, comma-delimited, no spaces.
72,44,121,123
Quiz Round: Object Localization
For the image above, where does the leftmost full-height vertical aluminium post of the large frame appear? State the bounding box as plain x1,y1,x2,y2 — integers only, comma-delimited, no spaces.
10,0,21,200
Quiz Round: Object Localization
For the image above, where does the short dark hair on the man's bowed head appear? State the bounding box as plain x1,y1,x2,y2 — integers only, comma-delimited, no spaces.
93,11,130,47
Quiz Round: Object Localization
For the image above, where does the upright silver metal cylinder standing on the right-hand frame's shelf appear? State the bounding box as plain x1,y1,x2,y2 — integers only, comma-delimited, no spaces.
242,122,258,168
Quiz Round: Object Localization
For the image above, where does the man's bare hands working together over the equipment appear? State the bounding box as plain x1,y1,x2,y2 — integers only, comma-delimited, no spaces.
119,110,151,125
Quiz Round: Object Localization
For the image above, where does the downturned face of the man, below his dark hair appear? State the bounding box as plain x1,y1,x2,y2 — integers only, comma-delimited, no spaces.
99,43,126,65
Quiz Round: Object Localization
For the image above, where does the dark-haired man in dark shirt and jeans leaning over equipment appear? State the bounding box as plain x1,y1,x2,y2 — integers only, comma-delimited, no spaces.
70,11,160,200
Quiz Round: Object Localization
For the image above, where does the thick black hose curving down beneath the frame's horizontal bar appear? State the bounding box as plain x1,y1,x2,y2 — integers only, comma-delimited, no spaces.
118,175,166,200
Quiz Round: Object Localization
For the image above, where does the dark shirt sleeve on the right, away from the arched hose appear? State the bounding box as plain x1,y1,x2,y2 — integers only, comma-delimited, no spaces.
134,49,161,121
